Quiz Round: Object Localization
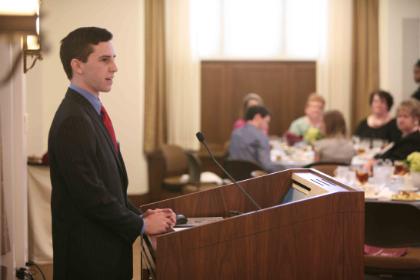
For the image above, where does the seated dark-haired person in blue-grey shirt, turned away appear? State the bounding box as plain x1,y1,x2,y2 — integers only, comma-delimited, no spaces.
229,106,284,172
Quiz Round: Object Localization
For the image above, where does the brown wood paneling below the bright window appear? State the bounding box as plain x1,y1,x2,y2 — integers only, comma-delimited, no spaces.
201,61,316,151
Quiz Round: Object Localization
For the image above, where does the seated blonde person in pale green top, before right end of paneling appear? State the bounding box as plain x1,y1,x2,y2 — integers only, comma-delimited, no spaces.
287,93,325,137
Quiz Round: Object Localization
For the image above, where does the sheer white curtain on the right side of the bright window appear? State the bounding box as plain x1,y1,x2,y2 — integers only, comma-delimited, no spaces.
317,0,352,126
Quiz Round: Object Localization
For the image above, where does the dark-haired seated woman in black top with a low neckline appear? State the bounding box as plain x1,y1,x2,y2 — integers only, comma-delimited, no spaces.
354,90,401,142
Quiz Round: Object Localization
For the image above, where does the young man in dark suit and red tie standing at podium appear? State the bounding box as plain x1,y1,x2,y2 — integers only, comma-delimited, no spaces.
48,27,175,280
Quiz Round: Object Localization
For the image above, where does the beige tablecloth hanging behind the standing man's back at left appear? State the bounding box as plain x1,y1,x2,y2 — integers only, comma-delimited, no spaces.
28,166,53,264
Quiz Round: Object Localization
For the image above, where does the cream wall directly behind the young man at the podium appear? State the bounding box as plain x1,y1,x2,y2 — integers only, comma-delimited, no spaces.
27,0,147,193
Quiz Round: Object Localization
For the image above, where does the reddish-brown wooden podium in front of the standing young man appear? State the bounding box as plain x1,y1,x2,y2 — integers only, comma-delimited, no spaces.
141,169,364,280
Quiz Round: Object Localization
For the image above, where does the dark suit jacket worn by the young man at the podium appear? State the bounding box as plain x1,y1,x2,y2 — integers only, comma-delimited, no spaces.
48,89,143,280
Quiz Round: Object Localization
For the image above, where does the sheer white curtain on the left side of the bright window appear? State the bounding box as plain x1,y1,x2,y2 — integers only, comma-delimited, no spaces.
165,0,201,149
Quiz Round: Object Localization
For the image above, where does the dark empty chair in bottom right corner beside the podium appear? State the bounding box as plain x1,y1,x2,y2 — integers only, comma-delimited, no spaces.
365,201,420,279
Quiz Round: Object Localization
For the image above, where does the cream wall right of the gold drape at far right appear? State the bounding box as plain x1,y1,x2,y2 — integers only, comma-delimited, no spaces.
379,0,420,110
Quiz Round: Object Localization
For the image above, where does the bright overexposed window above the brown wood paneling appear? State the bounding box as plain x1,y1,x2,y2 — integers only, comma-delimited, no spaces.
190,0,326,59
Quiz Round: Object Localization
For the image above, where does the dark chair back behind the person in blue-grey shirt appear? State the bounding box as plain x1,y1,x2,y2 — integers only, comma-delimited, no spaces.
224,159,267,181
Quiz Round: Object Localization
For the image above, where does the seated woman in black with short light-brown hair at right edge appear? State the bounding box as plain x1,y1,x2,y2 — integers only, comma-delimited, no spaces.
375,99,420,161
